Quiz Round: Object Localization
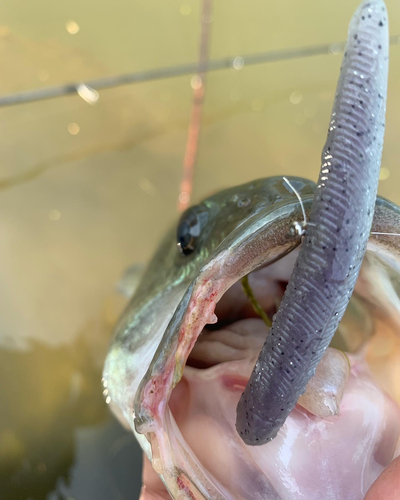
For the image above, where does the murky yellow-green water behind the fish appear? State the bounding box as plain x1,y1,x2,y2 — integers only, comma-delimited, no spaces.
0,0,400,500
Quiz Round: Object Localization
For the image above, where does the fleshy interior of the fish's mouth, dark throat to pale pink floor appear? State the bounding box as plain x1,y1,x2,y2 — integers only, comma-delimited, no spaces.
145,251,400,500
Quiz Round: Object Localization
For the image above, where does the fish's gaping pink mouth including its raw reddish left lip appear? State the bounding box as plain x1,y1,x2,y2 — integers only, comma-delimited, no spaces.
145,203,400,499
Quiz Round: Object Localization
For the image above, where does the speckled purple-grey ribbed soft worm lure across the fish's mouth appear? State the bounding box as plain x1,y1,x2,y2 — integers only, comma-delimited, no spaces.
236,0,388,445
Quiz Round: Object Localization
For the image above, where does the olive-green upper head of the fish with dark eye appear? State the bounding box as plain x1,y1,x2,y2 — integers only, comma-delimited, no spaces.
104,177,315,442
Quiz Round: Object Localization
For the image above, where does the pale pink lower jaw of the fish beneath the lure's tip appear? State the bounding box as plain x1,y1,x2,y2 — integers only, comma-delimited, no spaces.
151,358,400,500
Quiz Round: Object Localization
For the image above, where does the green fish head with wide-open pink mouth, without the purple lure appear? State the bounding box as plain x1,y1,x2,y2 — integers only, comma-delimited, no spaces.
104,177,400,500
